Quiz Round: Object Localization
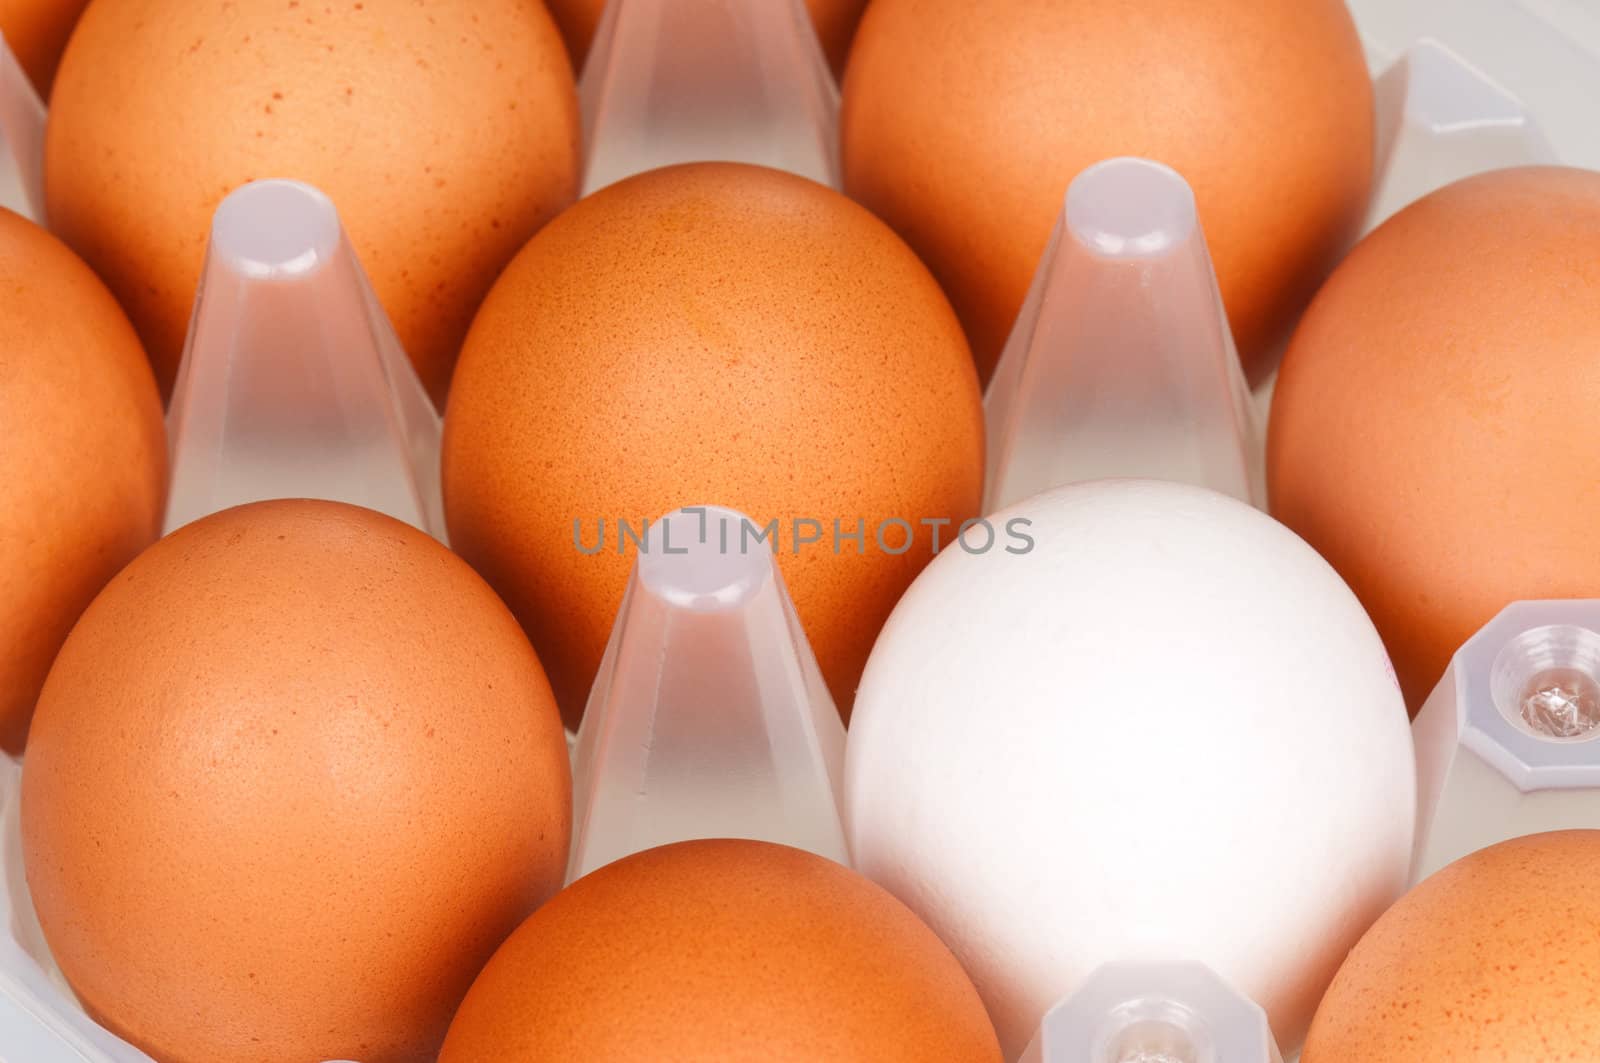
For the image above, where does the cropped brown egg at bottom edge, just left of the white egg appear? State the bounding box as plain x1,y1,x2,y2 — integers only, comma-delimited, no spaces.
440,840,1000,1063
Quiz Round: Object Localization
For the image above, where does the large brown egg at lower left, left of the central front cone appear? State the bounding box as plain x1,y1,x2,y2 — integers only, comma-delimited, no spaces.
22,501,571,1063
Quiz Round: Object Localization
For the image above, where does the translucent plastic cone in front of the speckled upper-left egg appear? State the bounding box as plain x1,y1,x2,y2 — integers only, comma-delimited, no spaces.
166,181,445,540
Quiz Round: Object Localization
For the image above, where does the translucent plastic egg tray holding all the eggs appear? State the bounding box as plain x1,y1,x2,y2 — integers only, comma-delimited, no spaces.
0,0,1600,1063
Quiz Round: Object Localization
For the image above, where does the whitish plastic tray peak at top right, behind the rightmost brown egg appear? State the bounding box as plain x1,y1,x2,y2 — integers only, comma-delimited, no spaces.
1366,38,1555,231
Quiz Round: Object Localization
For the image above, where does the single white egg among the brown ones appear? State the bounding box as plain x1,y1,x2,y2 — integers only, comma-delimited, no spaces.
845,480,1416,1058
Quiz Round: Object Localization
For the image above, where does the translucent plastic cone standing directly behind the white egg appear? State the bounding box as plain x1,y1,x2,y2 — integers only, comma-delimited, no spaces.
984,158,1264,512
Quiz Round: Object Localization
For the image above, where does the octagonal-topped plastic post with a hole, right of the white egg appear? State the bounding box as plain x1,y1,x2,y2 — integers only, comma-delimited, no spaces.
1411,599,1600,882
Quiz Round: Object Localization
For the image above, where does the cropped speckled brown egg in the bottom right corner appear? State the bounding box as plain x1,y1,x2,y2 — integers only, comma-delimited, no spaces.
1301,831,1600,1063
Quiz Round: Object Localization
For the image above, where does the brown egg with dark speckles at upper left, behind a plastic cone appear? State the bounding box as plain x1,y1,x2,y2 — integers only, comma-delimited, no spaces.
45,0,579,400
